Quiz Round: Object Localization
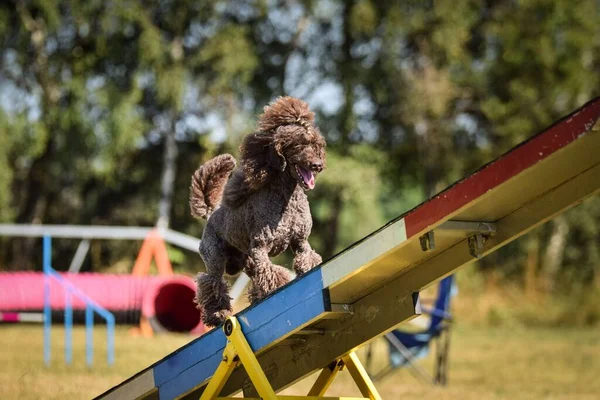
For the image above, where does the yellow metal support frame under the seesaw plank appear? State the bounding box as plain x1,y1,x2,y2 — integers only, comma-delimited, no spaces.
200,317,381,400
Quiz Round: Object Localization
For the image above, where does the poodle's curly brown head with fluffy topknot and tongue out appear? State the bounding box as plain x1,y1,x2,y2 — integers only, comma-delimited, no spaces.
241,97,326,190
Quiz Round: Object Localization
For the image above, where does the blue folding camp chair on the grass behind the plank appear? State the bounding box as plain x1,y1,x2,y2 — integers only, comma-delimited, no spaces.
366,275,454,385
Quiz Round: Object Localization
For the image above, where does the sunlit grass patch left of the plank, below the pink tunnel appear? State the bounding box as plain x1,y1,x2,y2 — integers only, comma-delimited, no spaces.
0,325,192,399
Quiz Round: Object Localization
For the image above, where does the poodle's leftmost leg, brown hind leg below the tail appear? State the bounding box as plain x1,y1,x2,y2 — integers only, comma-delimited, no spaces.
196,223,233,326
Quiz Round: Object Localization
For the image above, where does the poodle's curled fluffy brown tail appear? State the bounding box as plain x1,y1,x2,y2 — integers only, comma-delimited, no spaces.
190,154,236,219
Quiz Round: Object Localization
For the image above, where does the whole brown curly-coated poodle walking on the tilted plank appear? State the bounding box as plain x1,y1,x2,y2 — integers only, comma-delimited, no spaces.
190,97,325,326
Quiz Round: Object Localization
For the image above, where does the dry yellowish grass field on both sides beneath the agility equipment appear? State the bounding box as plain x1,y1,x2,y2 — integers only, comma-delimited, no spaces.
0,325,600,399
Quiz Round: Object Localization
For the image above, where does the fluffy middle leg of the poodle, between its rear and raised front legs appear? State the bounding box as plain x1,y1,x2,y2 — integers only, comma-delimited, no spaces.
244,247,292,304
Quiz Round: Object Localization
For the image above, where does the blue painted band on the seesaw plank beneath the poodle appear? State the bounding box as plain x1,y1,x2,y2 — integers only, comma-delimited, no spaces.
153,269,329,392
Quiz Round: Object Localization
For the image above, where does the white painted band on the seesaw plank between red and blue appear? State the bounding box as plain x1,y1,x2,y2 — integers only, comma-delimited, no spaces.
321,218,406,288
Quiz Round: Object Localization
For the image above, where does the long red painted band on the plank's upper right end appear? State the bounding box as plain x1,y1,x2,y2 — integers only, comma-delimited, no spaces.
404,98,600,238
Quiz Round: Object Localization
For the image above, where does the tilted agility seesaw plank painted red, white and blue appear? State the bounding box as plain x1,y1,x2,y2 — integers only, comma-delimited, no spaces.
99,99,600,399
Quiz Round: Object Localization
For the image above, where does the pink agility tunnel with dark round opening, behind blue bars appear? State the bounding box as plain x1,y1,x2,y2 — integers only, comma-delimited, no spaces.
0,272,205,334
